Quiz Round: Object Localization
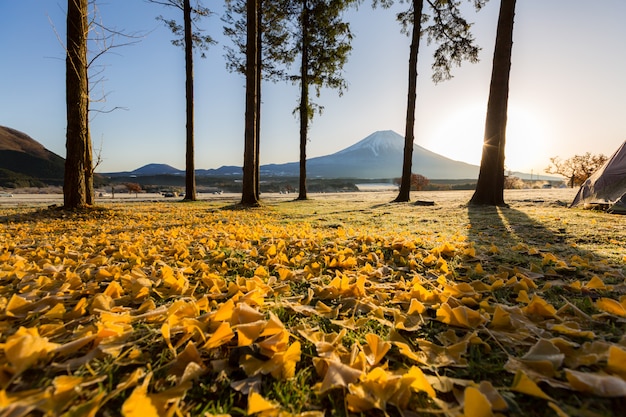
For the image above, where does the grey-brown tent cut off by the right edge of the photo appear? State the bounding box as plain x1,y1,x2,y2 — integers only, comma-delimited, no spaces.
570,141,626,214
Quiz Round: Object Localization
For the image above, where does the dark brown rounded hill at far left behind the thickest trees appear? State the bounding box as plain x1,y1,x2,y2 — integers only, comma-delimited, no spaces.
0,126,65,188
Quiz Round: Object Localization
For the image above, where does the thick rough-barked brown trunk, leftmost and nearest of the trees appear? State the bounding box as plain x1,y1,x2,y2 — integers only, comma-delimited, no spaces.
63,0,89,209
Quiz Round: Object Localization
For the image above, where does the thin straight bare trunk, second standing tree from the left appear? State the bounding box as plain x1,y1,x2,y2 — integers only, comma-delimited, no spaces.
183,0,196,201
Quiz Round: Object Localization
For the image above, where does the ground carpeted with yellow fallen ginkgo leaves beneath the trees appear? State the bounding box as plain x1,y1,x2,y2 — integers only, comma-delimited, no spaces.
0,193,626,417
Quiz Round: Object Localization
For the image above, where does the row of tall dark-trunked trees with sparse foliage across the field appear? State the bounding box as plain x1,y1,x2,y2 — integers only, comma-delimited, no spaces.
64,0,515,208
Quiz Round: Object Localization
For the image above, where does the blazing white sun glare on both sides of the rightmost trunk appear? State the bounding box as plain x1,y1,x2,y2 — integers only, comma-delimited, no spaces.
418,103,548,173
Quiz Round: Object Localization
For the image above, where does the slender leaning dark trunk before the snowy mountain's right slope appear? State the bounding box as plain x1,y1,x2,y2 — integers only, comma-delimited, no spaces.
394,0,424,202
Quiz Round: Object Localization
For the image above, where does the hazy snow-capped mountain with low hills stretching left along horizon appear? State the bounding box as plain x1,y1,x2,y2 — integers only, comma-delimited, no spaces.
103,130,479,179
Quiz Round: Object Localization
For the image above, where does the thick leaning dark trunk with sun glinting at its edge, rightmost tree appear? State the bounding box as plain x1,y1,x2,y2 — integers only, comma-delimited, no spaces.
470,0,515,206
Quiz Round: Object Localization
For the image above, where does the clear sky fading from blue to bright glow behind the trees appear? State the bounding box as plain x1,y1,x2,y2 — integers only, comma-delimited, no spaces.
0,0,626,173
